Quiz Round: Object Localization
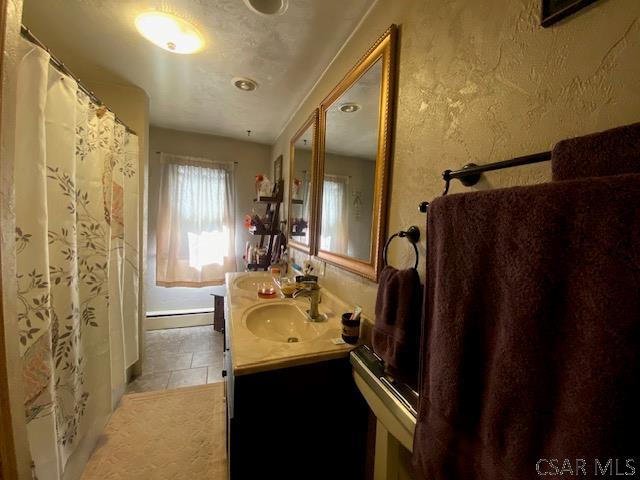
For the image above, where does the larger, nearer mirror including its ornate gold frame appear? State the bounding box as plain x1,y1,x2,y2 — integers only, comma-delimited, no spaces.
316,25,397,281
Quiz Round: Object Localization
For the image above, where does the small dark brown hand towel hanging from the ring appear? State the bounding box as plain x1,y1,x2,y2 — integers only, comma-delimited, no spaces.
372,266,423,385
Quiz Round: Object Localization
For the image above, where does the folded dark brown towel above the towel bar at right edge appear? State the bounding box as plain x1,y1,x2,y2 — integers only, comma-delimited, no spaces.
551,123,640,180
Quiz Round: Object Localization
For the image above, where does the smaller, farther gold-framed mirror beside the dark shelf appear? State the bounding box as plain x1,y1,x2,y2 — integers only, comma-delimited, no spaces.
287,108,319,253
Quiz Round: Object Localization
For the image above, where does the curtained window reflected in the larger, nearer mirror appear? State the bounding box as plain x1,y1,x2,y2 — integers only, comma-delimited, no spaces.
320,175,349,255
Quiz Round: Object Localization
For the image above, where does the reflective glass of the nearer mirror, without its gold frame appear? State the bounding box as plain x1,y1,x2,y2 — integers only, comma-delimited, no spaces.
320,59,382,261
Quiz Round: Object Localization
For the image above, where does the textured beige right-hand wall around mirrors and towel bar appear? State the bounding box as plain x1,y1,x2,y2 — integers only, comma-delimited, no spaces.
271,0,640,316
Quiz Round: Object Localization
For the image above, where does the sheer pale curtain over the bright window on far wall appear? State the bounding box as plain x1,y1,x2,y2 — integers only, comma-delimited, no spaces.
156,153,236,287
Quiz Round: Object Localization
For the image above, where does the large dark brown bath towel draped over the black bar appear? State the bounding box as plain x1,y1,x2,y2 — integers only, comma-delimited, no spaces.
413,175,640,480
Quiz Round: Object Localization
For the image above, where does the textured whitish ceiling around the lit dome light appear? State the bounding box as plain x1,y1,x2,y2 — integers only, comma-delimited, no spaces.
23,0,374,143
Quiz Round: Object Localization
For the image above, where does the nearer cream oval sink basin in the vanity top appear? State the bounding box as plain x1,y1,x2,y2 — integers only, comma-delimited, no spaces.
244,302,329,343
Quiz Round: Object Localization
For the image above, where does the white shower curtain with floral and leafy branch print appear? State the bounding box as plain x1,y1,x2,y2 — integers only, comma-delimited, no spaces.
15,40,139,480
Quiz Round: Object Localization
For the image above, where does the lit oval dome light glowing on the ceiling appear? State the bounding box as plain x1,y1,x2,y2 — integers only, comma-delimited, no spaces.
136,12,204,54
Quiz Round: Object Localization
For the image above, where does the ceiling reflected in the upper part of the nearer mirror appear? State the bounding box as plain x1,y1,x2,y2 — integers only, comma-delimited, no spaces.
325,59,382,161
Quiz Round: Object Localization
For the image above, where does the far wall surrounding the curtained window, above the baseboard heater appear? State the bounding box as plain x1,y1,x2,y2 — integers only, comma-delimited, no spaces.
146,127,272,312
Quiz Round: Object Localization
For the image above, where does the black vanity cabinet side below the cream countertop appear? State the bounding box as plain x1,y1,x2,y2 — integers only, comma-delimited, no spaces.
225,351,369,480
